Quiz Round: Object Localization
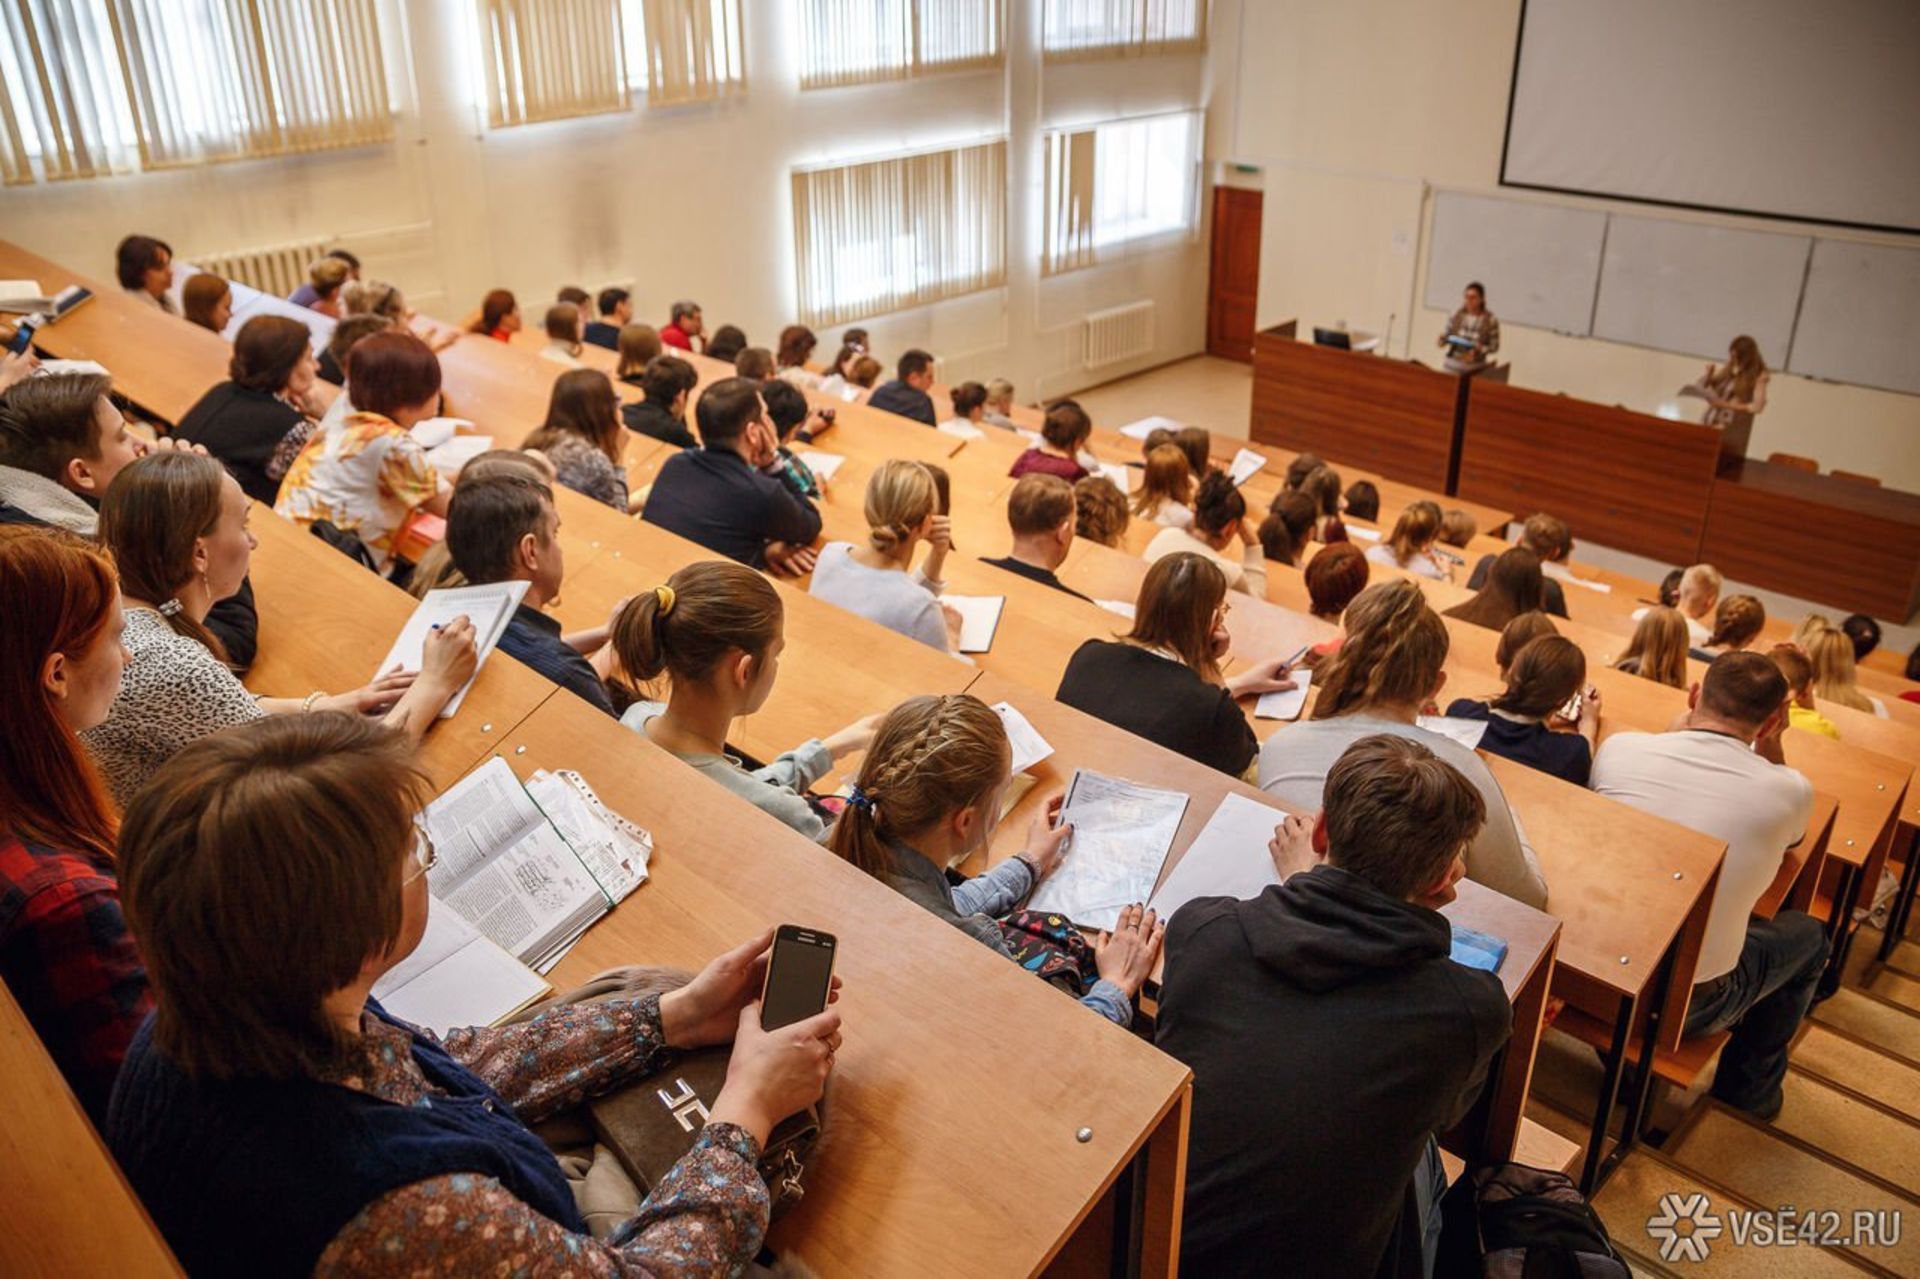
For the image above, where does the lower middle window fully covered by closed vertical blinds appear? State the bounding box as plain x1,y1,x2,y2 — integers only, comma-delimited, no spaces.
793,138,1006,325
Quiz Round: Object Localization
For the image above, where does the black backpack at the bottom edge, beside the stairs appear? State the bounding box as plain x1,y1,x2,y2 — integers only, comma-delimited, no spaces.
1440,1164,1632,1279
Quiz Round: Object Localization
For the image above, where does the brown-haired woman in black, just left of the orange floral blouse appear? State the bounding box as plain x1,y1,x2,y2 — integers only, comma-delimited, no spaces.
173,313,322,505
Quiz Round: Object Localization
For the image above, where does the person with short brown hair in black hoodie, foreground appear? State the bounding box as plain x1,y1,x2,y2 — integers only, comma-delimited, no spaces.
1154,730,1513,1277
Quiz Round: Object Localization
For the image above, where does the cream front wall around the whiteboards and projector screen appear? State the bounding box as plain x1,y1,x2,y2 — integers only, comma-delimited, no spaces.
1208,0,1920,490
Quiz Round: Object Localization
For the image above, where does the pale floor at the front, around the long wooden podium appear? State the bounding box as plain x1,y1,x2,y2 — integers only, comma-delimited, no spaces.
1073,355,1920,653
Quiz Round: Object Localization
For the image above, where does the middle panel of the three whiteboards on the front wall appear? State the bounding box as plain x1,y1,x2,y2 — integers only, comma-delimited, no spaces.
1594,213,1812,363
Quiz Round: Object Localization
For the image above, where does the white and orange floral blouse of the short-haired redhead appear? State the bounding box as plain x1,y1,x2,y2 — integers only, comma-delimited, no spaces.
273,413,440,572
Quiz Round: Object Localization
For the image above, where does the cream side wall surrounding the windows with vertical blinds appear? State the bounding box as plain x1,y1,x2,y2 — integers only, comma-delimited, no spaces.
0,0,1208,399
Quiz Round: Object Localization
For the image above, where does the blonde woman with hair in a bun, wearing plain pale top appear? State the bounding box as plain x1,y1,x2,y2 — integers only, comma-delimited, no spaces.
806,457,960,653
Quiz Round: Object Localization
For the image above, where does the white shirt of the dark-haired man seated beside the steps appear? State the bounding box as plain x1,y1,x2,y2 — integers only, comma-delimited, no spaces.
1590,728,1812,981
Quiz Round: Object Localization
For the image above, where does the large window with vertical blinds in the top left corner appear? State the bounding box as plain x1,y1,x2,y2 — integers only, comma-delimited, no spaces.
0,0,394,182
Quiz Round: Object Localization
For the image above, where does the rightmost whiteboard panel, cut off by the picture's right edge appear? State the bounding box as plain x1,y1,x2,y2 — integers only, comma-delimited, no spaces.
1788,240,1920,396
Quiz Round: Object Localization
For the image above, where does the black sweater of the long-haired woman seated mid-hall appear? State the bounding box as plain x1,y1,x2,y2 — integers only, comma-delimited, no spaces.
1054,640,1260,776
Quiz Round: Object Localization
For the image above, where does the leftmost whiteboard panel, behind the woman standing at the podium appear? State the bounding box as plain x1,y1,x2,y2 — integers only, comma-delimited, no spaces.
1427,192,1607,334
